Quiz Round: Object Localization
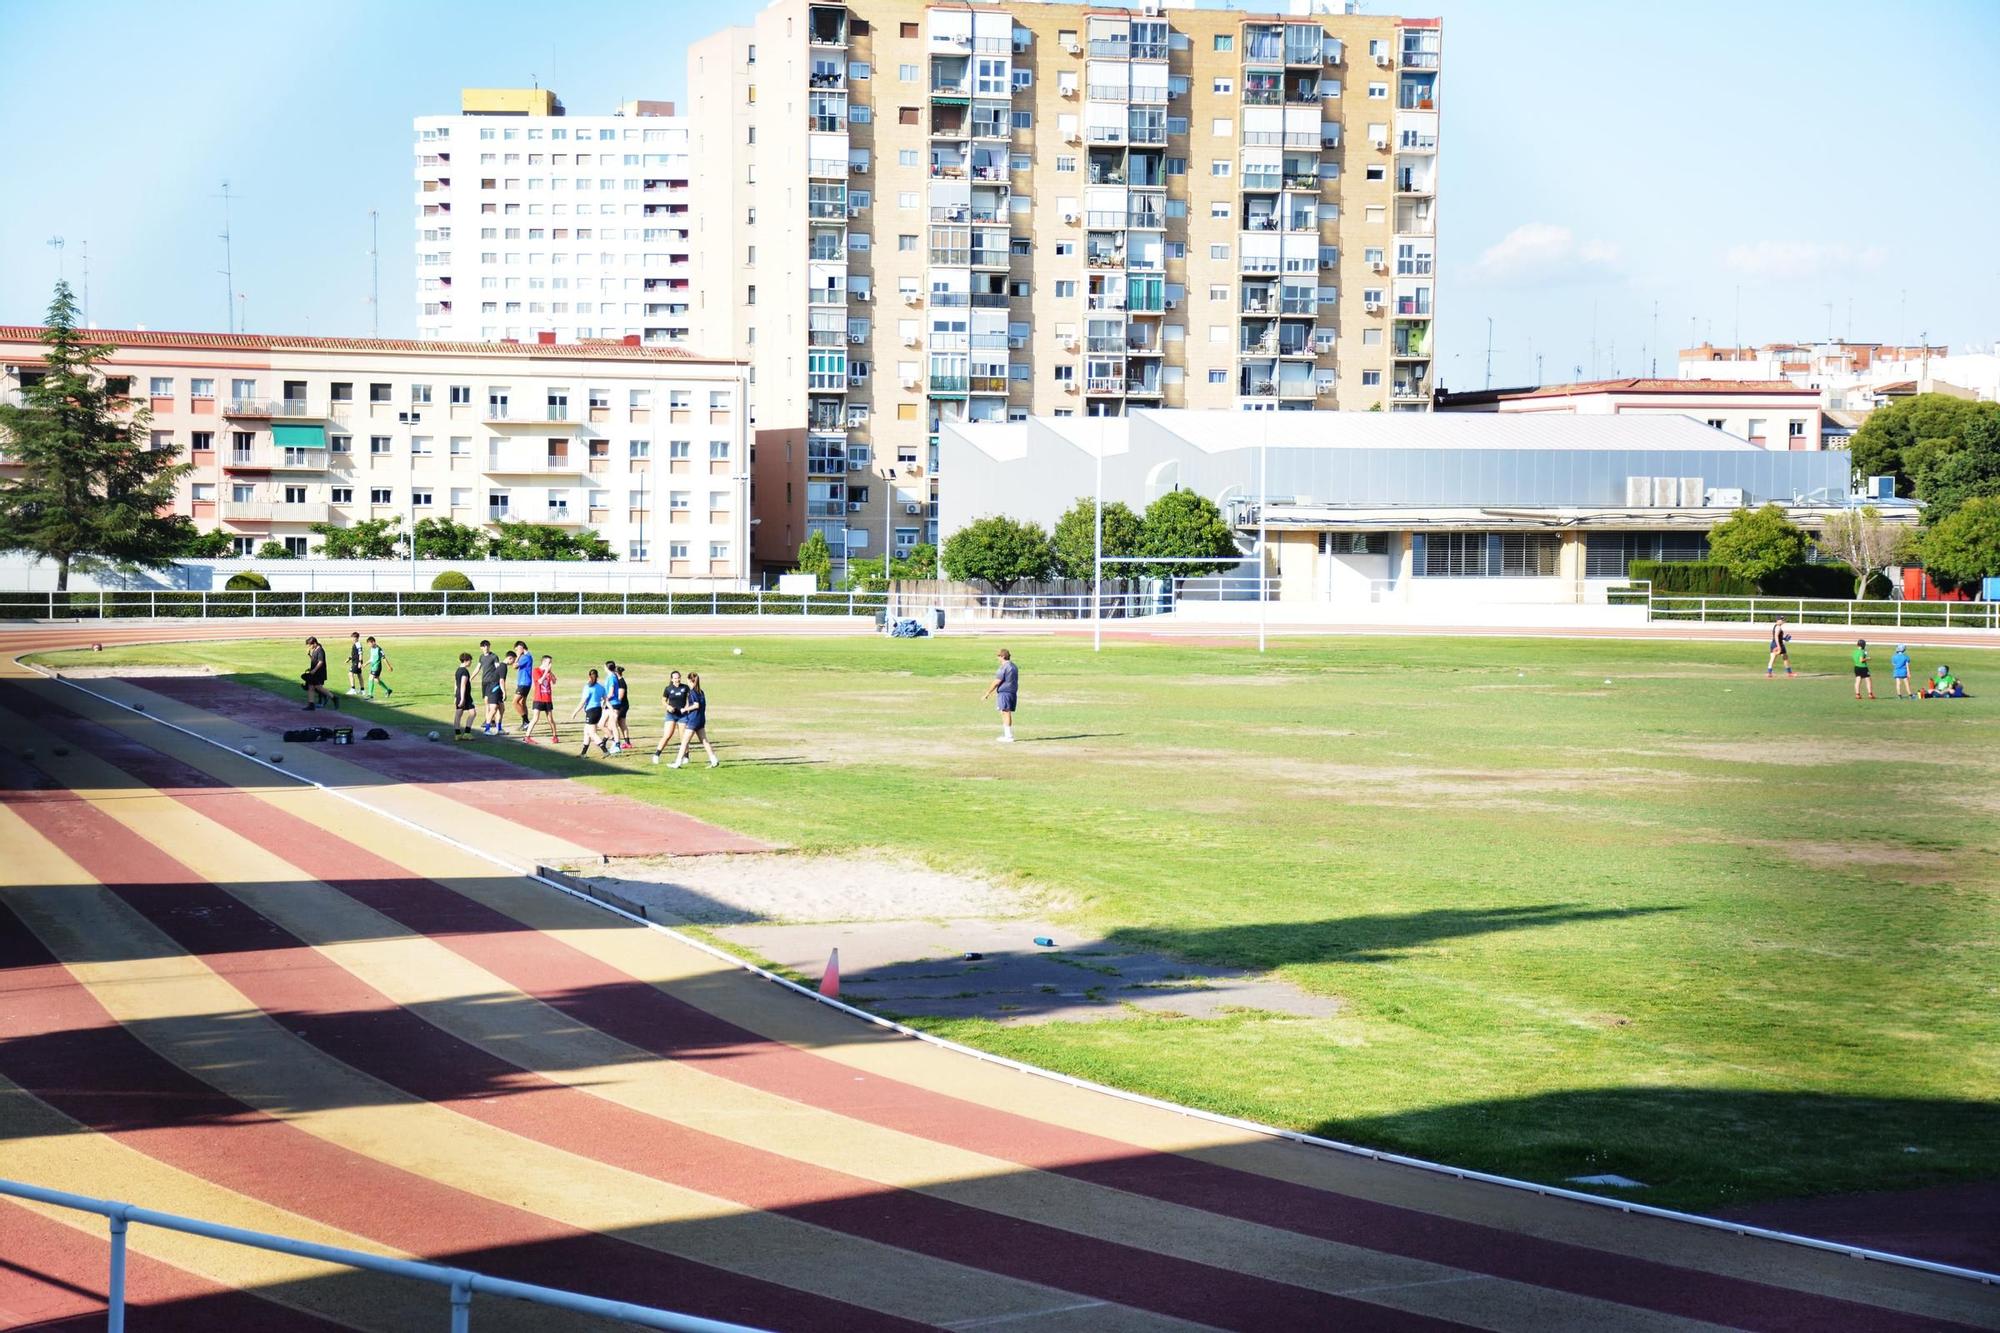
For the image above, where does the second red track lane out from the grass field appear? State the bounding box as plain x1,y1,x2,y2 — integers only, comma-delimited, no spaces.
0,717,1464,1329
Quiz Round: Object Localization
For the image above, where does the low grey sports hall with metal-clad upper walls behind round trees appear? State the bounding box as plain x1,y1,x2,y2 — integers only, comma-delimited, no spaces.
940,410,1916,604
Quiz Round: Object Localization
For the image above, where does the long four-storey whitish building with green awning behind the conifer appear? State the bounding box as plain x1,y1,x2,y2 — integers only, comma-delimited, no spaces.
0,326,750,588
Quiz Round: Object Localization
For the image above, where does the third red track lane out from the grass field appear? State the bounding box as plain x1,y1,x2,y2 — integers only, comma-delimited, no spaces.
0,896,922,1331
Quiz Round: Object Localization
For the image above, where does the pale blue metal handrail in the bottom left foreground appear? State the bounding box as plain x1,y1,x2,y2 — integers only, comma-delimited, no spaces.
0,1179,756,1333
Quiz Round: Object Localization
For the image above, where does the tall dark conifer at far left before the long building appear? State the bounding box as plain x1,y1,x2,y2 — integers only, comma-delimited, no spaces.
0,282,192,592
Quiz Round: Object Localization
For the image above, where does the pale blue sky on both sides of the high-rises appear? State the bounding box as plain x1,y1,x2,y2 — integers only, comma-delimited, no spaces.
0,0,2000,388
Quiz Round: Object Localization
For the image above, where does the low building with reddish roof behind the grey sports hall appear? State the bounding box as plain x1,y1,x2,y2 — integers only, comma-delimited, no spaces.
1436,378,1824,452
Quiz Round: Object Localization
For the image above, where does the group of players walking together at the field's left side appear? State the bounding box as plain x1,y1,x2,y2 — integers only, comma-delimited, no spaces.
300,630,722,769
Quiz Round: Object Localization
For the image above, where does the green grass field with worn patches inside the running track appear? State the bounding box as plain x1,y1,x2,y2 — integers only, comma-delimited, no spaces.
35,630,2000,1207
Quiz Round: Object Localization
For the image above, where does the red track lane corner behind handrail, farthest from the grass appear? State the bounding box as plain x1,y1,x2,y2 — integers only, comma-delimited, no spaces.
0,1199,346,1333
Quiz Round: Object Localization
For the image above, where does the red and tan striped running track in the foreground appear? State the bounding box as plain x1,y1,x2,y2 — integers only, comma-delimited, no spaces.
0,628,2000,1333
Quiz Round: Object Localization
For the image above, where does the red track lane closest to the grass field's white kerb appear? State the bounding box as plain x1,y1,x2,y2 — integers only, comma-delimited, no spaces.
3,684,1960,1333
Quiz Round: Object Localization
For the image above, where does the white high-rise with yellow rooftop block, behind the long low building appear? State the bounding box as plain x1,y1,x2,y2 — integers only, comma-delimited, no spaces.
416,88,690,346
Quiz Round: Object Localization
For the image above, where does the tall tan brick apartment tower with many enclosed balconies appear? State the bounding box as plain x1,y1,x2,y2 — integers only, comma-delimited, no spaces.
688,0,1442,564
